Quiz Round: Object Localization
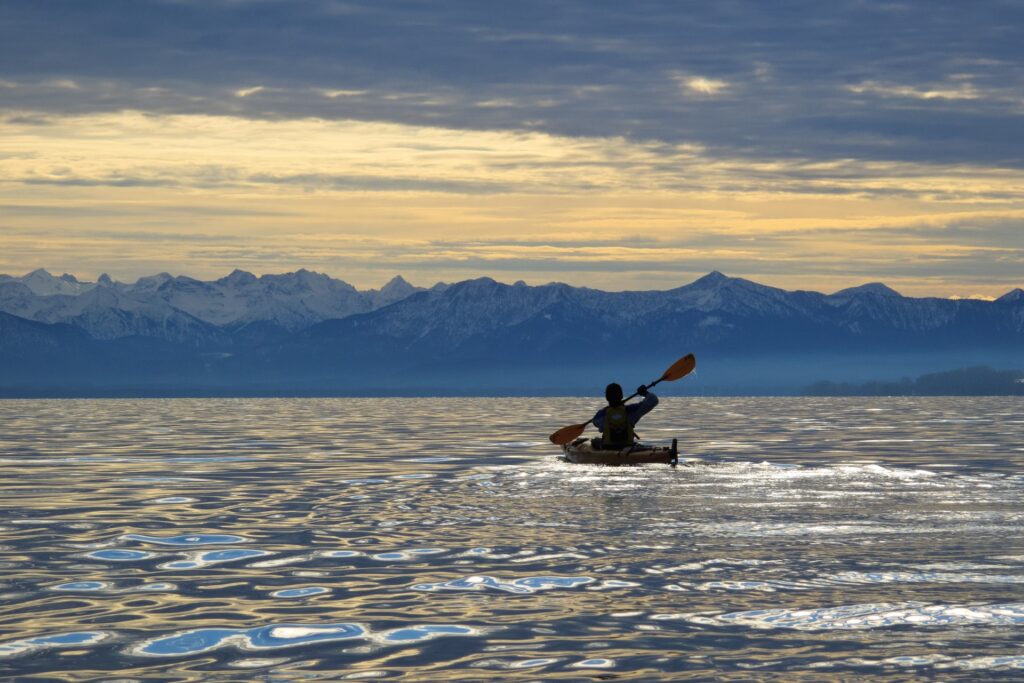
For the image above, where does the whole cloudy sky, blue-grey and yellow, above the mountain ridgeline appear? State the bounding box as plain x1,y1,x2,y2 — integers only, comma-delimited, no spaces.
0,0,1024,297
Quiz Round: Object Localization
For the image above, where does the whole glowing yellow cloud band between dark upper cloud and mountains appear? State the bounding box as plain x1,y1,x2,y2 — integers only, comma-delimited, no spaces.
0,110,1024,296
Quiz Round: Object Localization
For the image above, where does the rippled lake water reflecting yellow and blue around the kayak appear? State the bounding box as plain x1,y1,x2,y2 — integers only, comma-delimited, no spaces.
0,398,1024,681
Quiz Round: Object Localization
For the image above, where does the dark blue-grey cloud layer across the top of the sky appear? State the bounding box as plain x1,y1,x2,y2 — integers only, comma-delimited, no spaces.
0,0,1024,167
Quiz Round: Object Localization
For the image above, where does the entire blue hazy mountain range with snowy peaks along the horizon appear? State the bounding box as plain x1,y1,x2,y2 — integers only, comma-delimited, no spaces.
0,269,1024,395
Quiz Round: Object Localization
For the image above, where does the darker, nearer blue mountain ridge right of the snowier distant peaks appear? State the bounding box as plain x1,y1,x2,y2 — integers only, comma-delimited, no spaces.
276,273,1024,387
